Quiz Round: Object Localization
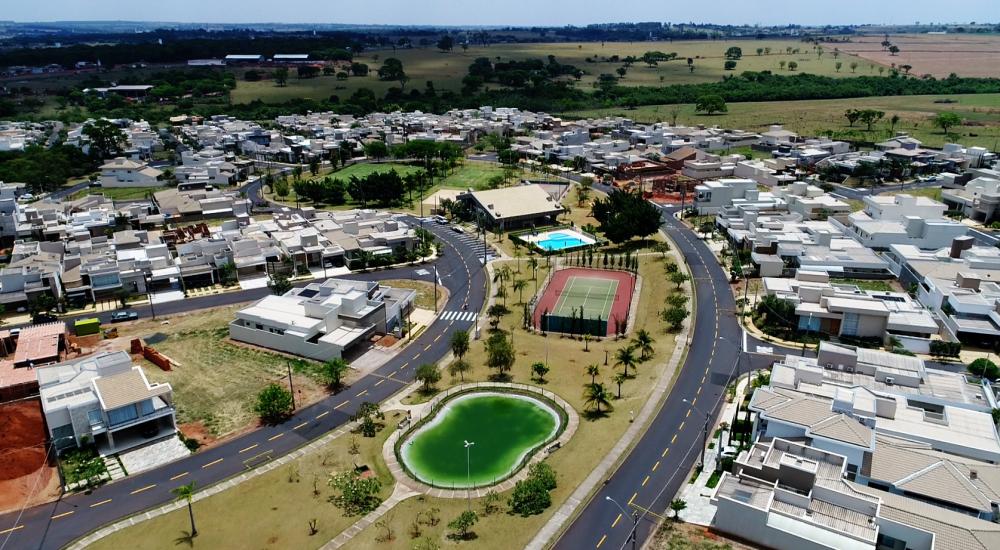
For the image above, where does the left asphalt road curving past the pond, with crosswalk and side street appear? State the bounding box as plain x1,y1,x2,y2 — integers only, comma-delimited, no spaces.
0,223,485,548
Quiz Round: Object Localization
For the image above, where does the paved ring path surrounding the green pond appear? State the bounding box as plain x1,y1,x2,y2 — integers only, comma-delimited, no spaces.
382,382,580,498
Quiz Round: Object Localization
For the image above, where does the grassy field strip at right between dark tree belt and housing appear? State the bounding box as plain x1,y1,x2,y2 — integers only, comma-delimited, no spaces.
563,94,1000,150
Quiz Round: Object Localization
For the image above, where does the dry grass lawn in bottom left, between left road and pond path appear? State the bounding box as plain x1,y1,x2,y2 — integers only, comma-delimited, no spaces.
91,412,400,550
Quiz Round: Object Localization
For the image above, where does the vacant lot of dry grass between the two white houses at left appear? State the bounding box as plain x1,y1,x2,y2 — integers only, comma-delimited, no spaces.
105,306,326,442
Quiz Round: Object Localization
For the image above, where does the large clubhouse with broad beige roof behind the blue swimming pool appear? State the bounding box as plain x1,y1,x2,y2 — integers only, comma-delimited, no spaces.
458,184,564,229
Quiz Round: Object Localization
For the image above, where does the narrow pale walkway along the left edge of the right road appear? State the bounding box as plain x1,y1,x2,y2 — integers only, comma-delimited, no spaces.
526,230,697,550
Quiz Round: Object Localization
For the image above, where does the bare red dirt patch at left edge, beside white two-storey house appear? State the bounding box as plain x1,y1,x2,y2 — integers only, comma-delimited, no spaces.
0,399,59,512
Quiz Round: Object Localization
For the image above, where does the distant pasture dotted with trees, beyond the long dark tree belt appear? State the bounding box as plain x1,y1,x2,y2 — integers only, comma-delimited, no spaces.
231,40,888,103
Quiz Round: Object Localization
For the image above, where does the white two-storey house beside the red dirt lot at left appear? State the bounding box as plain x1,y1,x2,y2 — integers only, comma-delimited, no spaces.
35,351,177,455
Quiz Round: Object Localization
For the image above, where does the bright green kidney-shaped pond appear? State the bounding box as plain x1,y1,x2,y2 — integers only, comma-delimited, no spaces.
400,393,559,488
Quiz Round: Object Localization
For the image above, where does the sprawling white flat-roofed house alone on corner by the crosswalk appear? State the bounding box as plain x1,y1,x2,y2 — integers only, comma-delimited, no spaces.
229,279,416,361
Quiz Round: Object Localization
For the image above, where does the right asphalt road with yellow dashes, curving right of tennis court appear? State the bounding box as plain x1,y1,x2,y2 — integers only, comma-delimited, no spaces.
556,208,772,550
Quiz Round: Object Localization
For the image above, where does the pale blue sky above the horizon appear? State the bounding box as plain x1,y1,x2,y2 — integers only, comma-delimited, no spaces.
0,0,997,26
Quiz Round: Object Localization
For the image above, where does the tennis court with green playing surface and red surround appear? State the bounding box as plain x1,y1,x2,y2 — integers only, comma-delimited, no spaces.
534,268,635,336
